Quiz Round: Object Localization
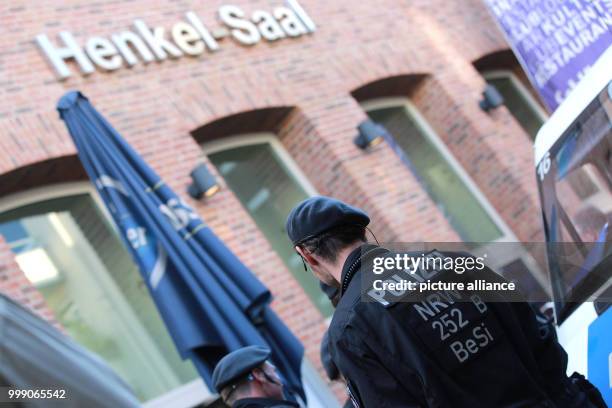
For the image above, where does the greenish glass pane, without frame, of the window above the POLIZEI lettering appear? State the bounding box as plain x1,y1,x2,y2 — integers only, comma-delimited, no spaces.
368,105,502,242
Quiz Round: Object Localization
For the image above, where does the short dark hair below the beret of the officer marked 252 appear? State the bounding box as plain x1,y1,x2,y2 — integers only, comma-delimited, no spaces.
299,224,366,262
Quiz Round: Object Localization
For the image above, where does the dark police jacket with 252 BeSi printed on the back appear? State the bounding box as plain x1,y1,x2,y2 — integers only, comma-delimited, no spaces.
329,246,588,408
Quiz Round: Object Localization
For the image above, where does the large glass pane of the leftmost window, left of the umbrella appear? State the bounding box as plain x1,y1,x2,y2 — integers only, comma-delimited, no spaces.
0,194,197,401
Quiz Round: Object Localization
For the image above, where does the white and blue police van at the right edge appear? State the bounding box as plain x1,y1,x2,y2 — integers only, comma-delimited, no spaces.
535,46,612,406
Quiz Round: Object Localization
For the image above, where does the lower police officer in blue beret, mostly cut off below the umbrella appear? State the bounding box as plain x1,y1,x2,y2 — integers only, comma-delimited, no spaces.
212,346,299,408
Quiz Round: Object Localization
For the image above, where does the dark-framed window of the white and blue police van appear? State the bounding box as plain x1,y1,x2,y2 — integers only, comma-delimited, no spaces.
537,82,612,320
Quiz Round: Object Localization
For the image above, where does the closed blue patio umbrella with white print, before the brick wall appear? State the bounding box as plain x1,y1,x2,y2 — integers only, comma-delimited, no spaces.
57,91,305,400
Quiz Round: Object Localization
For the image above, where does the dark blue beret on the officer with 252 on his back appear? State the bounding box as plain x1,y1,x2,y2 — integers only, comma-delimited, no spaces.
286,196,370,245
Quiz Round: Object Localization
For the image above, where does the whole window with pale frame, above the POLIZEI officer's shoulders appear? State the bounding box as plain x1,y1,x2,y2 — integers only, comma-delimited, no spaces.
361,97,547,299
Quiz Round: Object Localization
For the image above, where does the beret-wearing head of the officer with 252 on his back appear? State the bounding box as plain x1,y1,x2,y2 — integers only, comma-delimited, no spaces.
287,196,370,287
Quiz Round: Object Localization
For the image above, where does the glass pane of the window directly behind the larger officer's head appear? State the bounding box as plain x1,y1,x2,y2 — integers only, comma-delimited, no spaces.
208,142,332,316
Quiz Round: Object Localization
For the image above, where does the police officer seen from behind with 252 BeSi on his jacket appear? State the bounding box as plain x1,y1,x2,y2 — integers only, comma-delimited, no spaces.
286,197,592,408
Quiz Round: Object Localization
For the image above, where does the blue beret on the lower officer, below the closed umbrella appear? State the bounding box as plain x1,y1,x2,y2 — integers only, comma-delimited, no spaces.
212,346,270,392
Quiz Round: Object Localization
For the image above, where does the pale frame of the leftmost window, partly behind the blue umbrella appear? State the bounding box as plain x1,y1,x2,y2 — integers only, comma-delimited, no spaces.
0,181,216,408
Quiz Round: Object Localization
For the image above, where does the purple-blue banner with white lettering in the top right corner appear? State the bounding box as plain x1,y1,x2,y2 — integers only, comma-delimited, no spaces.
486,0,612,111
